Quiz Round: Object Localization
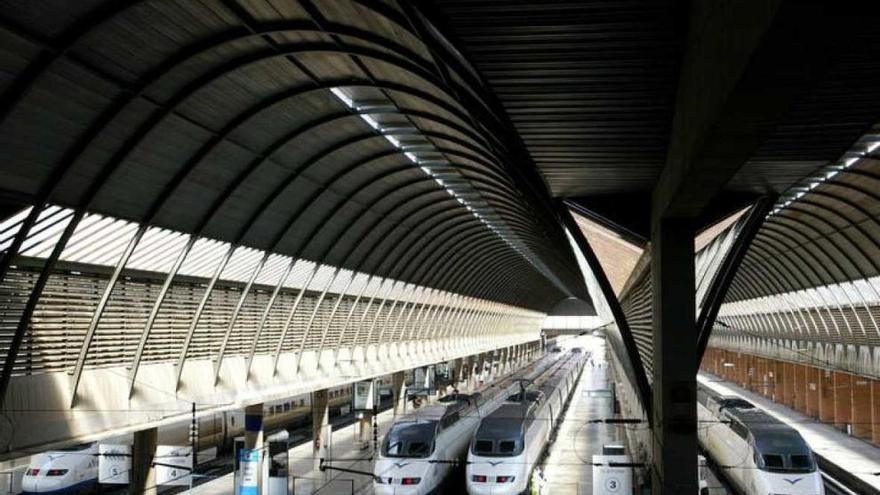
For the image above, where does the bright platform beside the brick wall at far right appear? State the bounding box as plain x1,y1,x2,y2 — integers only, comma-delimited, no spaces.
697,371,880,490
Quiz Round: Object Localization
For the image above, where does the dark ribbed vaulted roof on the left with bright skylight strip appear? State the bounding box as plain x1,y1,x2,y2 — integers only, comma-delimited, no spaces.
0,0,589,310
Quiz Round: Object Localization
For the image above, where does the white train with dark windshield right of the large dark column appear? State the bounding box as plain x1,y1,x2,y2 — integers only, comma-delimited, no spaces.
697,385,825,495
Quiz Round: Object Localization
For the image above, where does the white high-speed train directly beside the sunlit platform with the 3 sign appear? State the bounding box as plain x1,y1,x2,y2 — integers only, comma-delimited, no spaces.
465,352,584,495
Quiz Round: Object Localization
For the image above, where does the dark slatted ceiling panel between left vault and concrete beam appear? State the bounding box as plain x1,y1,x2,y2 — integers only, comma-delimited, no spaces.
427,0,685,197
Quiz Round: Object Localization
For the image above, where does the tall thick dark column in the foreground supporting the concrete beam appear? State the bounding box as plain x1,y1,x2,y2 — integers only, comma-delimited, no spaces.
651,218,698,495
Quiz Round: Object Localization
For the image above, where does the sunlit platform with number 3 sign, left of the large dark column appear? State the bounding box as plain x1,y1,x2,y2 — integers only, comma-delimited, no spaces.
541,337,625,495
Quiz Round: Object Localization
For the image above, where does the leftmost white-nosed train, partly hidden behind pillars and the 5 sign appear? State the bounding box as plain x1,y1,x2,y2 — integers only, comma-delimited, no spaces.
22,379,391,495
